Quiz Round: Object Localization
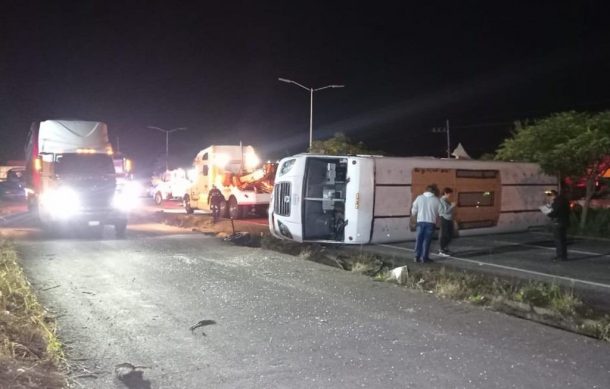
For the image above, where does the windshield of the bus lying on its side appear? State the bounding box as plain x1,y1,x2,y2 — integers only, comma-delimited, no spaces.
303,157,347,241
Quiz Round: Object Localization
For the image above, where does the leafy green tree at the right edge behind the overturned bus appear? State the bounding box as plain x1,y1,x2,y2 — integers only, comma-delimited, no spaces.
496,111,610,229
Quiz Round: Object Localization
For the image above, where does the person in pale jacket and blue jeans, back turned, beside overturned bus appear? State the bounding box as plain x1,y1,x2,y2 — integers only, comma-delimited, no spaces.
411,184,440,263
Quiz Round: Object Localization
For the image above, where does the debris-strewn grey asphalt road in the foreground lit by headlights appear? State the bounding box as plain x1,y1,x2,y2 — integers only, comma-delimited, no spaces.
11,224,610,388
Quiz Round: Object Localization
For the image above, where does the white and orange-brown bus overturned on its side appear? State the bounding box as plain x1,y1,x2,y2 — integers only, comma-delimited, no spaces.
269,154,559,244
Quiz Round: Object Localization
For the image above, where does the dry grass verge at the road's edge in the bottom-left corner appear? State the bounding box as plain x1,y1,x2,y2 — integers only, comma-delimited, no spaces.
0,241,65,389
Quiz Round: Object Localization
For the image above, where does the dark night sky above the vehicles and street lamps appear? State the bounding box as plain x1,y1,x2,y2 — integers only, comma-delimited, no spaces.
0,1,610,170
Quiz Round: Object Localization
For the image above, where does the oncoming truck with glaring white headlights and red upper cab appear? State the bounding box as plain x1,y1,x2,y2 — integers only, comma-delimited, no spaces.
25,120,136,236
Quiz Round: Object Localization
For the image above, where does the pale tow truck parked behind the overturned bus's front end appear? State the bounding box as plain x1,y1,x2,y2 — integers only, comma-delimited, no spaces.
183,146,275,219
